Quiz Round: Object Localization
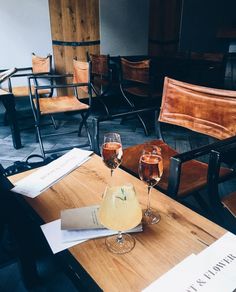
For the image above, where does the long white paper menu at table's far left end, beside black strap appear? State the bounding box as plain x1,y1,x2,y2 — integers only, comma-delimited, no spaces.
12,148,93,198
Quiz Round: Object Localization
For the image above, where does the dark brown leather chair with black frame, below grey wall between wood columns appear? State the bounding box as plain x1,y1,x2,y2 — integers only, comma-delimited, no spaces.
120,58,161,135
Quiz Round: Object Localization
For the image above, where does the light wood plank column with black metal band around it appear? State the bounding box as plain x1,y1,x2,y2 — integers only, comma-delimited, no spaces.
48,0,100,73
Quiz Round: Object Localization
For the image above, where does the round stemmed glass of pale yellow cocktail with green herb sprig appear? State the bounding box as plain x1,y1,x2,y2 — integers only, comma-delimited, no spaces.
98,184,142,254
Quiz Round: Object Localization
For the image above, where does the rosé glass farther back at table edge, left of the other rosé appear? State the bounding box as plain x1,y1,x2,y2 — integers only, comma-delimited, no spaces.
102,133,123,177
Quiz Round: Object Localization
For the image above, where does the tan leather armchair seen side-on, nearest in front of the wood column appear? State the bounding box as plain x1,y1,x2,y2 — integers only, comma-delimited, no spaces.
29,60,92,157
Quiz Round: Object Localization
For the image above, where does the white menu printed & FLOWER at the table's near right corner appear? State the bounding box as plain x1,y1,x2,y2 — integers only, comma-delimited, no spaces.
143,232,236,292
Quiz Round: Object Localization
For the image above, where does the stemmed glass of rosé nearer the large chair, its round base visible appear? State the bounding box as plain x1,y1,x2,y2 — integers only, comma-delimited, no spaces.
138,144,163,224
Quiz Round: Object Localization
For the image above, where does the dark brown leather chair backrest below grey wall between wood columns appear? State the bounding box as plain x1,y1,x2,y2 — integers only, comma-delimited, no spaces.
120,58,150,84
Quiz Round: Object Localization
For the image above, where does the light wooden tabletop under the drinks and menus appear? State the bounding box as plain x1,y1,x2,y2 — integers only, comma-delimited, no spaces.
10,154,226,291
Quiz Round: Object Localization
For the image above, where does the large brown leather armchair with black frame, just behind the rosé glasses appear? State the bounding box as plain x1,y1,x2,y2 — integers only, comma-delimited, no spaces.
122,77,236,209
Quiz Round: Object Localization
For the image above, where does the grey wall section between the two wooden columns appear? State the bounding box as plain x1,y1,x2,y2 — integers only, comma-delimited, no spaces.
100,0,149,56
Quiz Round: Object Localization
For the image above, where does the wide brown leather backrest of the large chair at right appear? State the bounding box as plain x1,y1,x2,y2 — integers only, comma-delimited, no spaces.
159,77,236,140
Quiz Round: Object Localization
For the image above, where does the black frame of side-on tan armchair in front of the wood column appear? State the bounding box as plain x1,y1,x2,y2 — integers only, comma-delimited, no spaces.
28,74,92,157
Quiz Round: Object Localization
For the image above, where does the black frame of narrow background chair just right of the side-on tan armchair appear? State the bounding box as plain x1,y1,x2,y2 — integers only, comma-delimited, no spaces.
87,52,112,116
